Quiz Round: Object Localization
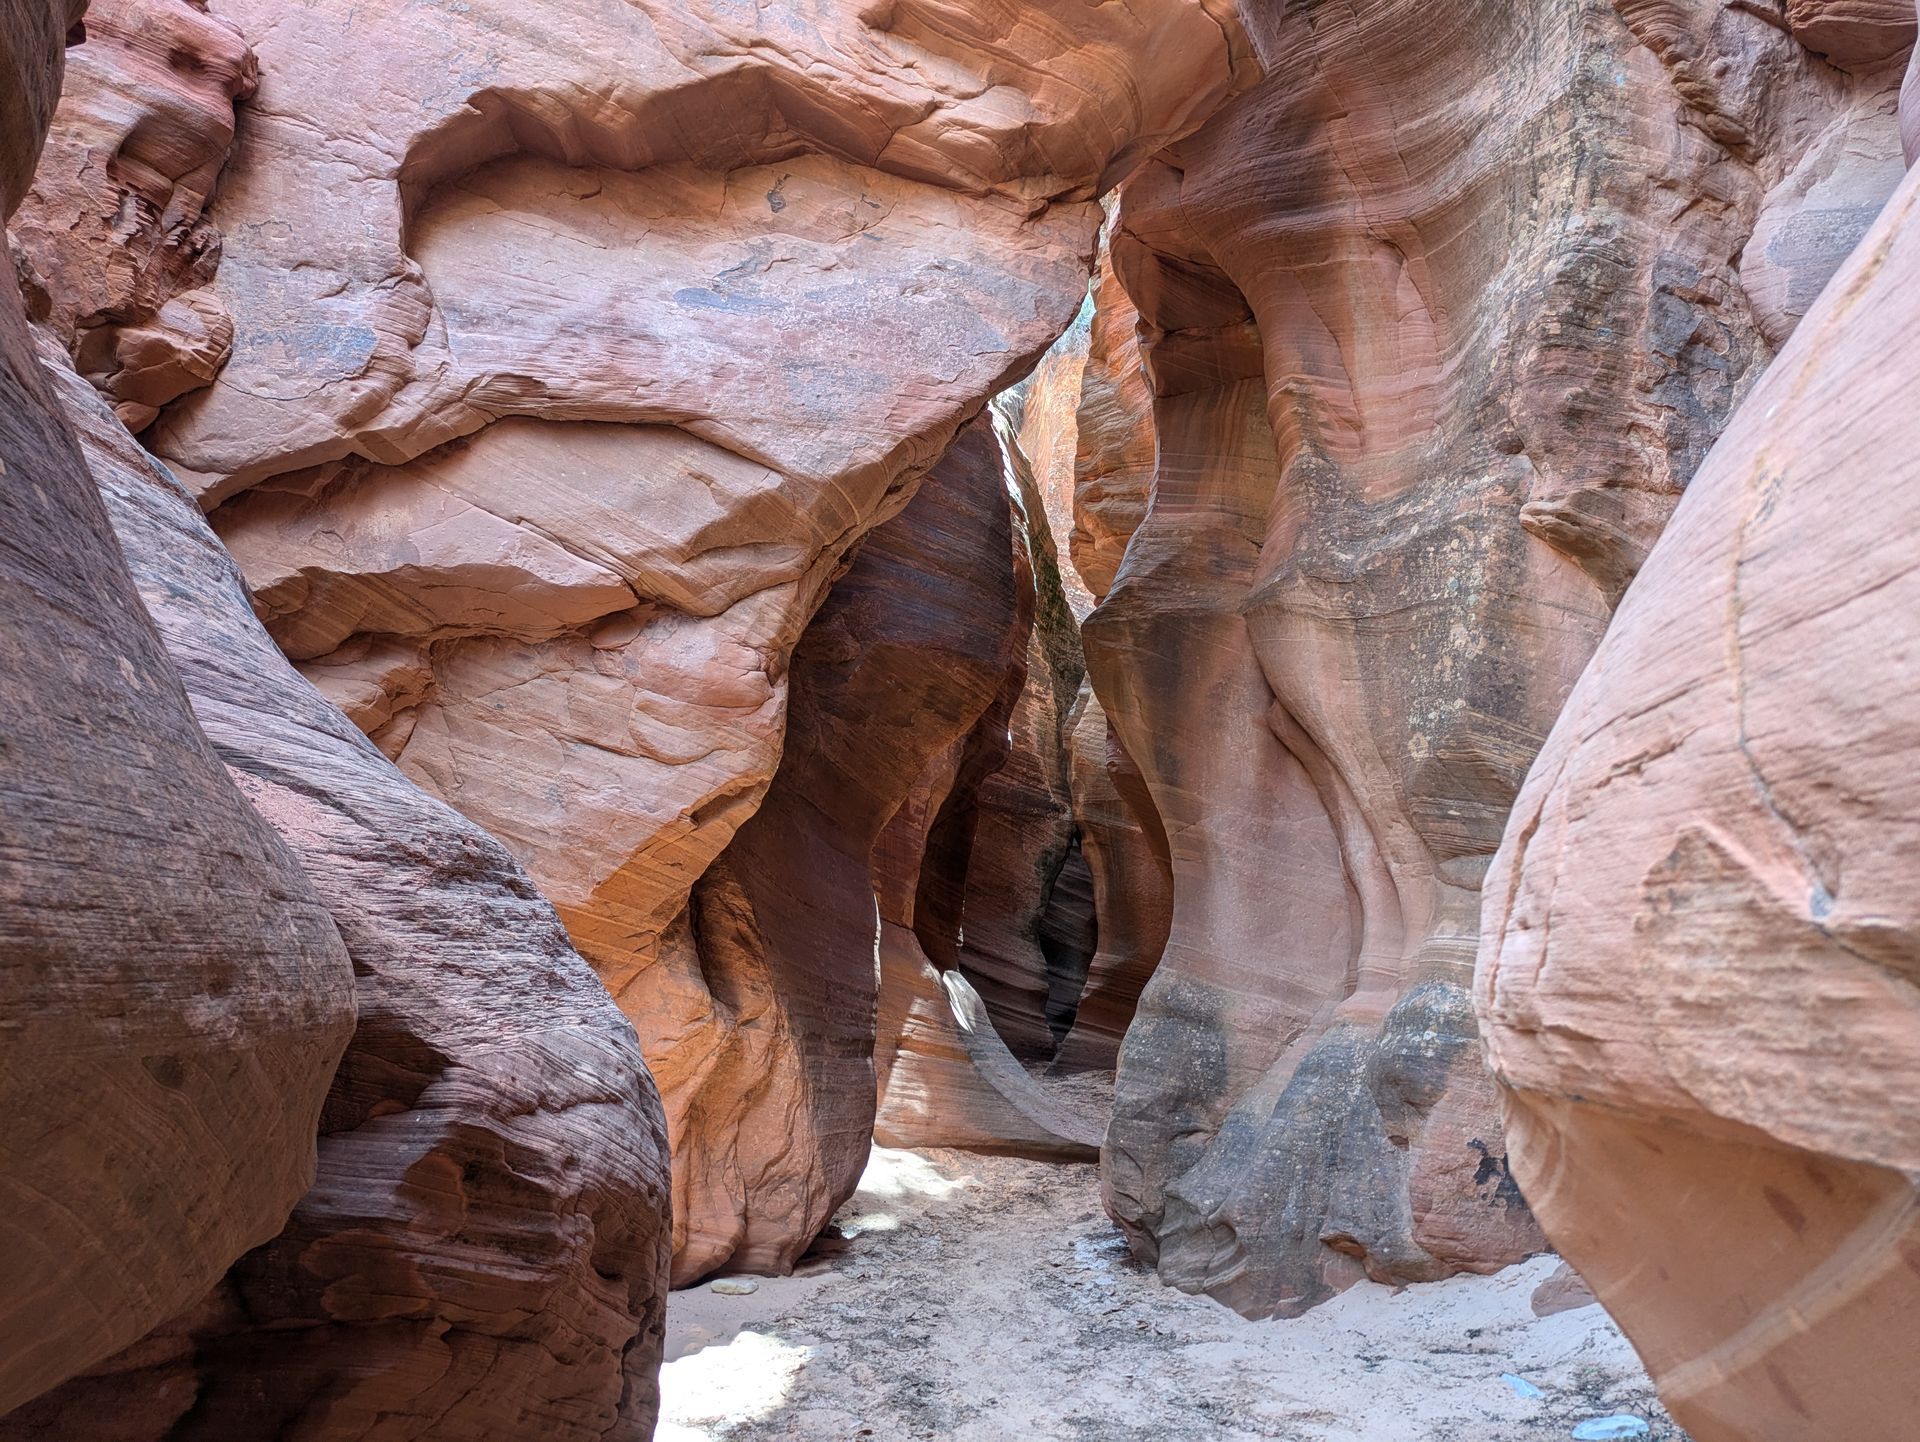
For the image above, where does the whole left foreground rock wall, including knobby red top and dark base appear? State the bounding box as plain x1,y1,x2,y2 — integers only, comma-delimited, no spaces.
0,0,670,1442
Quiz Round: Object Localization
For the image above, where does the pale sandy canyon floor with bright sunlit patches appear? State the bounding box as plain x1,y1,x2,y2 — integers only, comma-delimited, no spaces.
659,1148,1684,1442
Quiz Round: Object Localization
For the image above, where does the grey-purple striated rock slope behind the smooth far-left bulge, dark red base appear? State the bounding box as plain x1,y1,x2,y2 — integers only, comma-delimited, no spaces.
0,349,670,1442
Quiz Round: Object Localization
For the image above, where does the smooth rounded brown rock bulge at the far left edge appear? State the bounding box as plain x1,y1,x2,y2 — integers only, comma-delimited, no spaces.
0,4,353,1411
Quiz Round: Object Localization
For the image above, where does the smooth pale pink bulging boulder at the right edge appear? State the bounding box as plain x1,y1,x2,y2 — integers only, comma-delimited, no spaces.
1476,163,1920,1442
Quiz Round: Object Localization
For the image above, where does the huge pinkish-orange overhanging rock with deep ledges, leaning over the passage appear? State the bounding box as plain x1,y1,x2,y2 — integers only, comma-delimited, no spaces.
183,0,1246,1265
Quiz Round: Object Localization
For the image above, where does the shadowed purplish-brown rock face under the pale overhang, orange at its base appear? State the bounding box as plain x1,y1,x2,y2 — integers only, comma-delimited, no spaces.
659,417,1014,1281
